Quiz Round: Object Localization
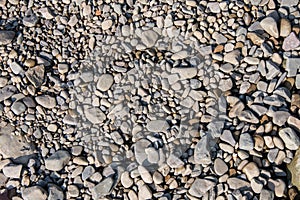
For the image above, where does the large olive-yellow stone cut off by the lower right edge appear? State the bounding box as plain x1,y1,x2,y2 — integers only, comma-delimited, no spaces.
287,148,300,190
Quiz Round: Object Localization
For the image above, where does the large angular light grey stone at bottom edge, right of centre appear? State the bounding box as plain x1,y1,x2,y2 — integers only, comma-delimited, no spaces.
188,178,216,198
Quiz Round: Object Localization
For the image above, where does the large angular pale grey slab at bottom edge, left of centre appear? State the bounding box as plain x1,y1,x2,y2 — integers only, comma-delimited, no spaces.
91,177,114,199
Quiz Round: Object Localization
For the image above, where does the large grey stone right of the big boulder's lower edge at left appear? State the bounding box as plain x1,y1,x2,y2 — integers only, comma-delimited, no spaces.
45,150,71,171
